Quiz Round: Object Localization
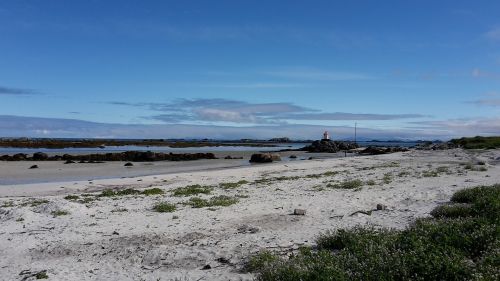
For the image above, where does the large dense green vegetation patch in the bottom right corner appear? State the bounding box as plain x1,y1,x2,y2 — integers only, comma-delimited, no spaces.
246,185,500,281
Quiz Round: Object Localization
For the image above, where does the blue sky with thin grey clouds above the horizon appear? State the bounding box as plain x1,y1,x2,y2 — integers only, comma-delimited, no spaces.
0,0,500,139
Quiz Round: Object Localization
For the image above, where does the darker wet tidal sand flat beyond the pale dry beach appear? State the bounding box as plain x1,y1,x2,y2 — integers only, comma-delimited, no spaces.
0,150,352,185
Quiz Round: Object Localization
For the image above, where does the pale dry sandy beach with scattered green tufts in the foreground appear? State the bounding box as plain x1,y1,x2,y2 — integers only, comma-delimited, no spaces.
0,149,500,280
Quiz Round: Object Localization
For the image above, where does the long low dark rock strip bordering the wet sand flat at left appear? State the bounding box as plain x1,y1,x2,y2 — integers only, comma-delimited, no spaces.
0,151,217,163
